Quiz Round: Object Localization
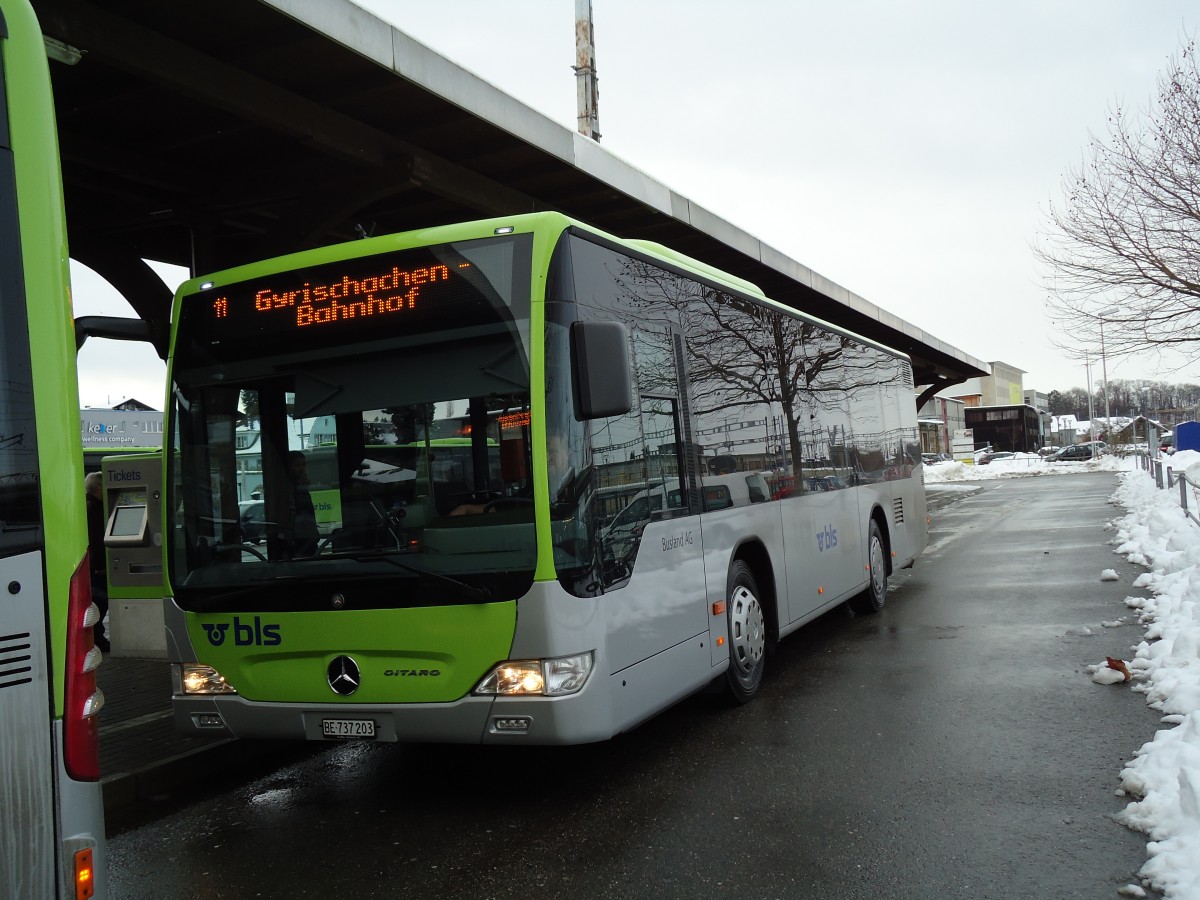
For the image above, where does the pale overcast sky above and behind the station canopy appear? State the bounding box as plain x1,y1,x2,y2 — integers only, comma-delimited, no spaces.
76,0,1200,406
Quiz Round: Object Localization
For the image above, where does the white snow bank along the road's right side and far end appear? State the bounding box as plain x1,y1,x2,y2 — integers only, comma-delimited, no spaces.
925,451,1200,900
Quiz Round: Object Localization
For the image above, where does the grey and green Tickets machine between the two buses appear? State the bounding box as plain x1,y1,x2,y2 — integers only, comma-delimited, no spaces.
101,451,167,659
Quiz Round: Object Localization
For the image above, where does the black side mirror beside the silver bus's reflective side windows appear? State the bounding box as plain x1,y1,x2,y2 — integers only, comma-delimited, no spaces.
571,322,634,421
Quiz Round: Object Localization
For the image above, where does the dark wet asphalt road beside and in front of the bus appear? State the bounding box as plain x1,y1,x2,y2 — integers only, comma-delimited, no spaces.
109,474,1158,900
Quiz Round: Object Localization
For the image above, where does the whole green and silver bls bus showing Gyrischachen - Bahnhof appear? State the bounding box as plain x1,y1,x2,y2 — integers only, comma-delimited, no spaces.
164,214,926,744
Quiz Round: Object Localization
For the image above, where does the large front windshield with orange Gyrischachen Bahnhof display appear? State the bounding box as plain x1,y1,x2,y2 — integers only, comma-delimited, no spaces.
168,232,535,611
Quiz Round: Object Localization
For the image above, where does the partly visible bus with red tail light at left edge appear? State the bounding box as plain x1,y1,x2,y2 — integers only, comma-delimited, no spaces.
0,0,106,899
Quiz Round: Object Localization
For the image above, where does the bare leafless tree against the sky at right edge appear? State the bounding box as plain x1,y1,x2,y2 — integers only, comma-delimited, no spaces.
1037,36,1200,361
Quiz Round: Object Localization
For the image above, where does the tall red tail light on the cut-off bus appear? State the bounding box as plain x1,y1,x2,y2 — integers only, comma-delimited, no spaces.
62,553,104,781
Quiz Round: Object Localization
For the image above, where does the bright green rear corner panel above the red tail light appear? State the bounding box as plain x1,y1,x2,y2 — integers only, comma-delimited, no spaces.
4,2,88,718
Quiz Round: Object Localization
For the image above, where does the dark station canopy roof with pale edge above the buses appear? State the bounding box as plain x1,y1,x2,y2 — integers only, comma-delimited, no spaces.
32,0,989,392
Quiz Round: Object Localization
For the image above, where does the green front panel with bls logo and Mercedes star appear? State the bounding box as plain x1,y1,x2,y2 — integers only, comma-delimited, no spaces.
187,601,517,704
